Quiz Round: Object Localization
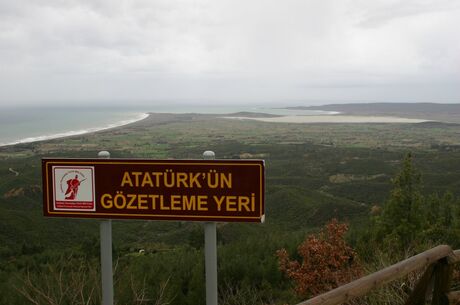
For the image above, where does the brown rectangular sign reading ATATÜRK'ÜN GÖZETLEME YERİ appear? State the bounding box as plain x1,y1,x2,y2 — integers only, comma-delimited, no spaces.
42,159,264,222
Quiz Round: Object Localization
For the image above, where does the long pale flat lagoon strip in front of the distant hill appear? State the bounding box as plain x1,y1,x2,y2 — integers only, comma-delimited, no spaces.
224,115,429,124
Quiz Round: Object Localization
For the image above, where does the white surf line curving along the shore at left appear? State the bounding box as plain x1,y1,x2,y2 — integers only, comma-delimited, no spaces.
0,113,149,147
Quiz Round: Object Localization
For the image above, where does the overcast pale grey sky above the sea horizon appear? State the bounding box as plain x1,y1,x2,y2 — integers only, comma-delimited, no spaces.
0,0,460,105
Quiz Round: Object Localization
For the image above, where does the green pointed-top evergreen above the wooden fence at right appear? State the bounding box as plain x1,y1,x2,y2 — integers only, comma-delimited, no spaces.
368,153,460,255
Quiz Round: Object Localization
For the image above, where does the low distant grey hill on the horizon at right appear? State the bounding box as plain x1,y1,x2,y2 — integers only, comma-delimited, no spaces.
288,103,460,123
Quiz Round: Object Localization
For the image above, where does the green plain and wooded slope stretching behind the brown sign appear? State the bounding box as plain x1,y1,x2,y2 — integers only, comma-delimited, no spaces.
0,114,460,305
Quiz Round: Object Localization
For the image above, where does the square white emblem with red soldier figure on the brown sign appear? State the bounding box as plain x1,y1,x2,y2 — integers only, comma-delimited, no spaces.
53,166,96,211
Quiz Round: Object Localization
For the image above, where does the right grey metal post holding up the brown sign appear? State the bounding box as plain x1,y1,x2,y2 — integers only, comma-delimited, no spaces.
203,150,217,305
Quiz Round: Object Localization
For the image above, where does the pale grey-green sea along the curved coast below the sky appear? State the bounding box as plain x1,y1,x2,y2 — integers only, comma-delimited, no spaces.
0,104,331,146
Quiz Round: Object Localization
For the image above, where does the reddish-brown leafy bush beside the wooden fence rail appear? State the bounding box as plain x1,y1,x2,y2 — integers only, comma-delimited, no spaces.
277,219,362,296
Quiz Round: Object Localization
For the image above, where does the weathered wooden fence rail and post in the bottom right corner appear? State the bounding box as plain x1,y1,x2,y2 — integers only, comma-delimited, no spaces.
297,245,460,305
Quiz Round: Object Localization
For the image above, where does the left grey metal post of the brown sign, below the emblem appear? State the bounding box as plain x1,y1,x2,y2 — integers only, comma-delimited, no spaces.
98,151,113,305
